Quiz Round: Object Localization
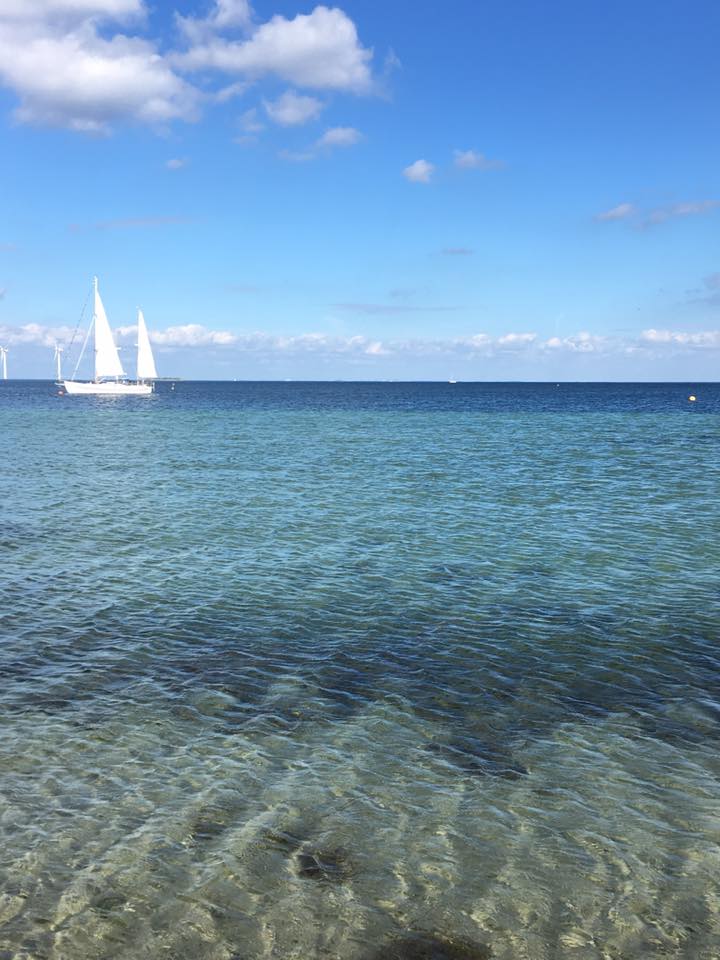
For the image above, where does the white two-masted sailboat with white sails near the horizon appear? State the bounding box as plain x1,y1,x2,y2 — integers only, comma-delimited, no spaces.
62,277,157,397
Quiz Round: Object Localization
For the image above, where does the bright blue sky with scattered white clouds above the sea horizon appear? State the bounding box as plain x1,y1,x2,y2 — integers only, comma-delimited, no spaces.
0,0,720,381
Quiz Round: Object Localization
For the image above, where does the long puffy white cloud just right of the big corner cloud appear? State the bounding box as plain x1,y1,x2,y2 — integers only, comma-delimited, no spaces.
174,6,372,93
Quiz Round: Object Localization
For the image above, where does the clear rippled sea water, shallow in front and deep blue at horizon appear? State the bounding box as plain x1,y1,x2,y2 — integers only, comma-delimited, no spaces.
0,381,720,960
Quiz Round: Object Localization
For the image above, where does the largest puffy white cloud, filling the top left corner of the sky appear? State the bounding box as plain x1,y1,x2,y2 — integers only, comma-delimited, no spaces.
0,0,198,133
